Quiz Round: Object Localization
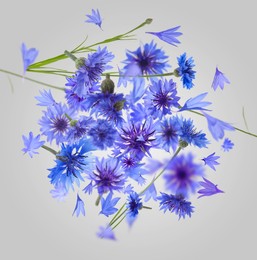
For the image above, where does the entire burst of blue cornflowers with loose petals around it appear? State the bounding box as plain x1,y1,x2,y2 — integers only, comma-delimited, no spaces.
22,10,235,239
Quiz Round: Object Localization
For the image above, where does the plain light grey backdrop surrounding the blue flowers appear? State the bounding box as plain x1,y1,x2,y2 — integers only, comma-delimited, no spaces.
0,0,257,260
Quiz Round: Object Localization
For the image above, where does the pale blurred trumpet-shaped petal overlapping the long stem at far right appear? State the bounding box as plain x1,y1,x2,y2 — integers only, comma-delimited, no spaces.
203,113,235,141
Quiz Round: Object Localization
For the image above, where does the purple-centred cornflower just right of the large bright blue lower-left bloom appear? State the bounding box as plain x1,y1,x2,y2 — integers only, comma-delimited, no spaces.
91,158,126,195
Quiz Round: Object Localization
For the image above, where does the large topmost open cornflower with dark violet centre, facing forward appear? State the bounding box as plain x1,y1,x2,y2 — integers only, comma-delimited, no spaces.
124,41,169,76
